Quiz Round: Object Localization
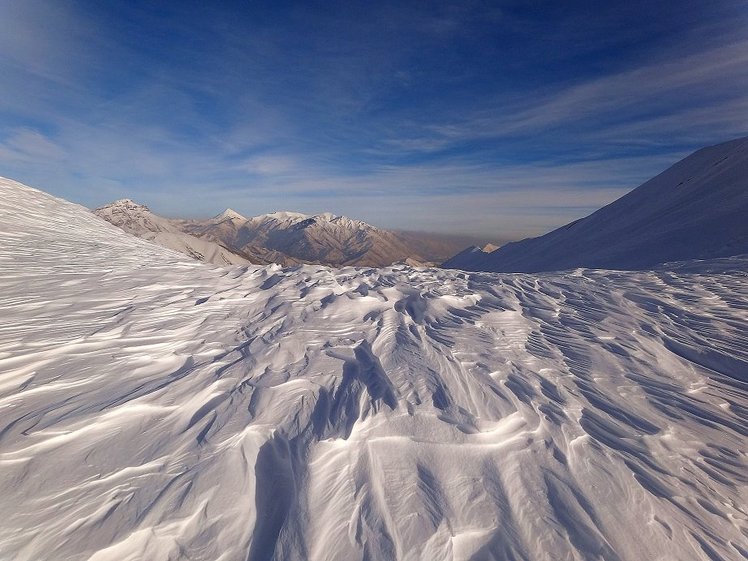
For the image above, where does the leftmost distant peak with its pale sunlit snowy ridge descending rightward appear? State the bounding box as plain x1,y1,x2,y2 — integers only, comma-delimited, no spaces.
94,199,250,265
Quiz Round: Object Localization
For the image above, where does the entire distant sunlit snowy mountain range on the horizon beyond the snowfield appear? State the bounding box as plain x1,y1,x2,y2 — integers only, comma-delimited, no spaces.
94,199,464,267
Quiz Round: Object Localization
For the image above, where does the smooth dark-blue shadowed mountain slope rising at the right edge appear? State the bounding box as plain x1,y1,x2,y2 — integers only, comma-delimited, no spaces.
443,138,748,271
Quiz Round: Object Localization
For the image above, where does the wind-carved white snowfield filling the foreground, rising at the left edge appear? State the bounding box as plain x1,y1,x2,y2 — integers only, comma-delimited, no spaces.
0,180,748,561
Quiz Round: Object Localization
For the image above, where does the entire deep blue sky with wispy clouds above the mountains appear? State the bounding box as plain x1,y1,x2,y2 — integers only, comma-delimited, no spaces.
0,0,748,240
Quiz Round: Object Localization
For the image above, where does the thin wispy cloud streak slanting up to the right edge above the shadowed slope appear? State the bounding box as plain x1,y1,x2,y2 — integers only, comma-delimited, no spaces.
389,40,748,152
